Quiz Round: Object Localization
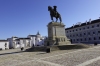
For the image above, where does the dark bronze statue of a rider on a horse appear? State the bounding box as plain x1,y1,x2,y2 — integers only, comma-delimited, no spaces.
48,6,62,23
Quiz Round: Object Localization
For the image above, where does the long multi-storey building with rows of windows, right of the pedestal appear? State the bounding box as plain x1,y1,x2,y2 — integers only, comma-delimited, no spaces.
65,19,100,44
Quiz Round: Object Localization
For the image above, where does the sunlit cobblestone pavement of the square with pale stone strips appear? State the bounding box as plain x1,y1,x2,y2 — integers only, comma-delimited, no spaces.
0,46,100,66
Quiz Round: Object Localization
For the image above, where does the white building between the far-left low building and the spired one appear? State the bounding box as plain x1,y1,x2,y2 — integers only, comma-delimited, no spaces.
7,37,31,49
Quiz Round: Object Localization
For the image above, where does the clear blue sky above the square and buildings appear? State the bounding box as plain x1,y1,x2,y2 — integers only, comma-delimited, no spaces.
0,0,100,39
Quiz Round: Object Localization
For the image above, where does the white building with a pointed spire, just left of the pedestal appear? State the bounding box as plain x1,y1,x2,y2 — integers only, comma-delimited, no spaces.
27,32,46,46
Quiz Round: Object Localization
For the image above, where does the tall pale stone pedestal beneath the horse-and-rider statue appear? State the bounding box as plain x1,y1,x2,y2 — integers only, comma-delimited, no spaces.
46,22,71,45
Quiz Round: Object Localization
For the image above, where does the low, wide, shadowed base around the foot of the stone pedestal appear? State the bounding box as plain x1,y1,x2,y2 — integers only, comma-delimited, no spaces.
26,44,91,51
